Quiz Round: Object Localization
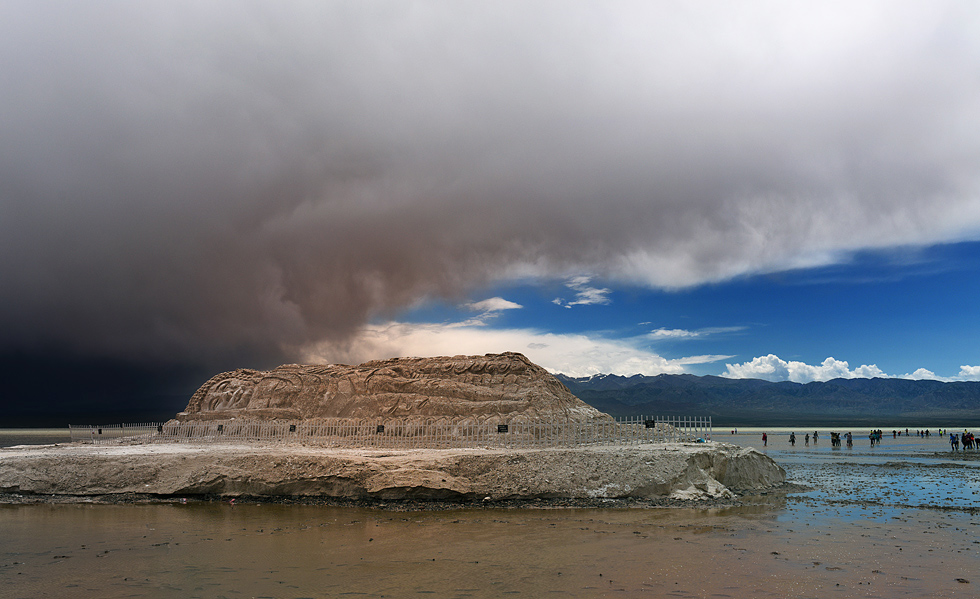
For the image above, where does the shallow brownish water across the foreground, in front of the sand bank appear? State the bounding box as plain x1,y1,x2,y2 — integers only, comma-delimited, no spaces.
0,499,980,598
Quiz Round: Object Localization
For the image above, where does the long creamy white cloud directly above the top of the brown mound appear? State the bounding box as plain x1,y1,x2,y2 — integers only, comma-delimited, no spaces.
301,322,731,376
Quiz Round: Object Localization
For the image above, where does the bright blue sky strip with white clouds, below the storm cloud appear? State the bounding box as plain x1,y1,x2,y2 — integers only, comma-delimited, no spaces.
318,242,980,382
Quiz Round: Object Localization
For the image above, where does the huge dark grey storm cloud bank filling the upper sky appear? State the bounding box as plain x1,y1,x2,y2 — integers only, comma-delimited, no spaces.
0,0,980,412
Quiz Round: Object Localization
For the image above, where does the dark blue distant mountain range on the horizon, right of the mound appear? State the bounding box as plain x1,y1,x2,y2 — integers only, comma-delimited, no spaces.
556,374,980,427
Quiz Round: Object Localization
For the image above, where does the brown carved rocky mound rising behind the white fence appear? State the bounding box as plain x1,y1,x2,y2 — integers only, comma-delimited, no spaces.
177,353,609,421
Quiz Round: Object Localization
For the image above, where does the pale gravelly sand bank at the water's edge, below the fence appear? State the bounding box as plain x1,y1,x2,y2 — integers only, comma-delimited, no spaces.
0,443,785,501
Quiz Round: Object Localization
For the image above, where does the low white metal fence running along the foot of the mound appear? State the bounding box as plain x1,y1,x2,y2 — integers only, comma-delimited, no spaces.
68,416,712,449
